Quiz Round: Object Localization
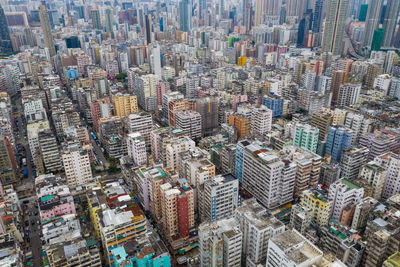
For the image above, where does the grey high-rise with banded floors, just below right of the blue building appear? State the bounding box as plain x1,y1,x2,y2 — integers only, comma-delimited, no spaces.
340,146,369,180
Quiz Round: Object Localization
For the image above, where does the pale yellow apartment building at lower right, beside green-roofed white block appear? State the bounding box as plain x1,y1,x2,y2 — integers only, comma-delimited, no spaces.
300,188,332,226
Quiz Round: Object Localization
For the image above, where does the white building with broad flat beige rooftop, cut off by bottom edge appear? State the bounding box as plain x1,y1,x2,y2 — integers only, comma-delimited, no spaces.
266,230,323,267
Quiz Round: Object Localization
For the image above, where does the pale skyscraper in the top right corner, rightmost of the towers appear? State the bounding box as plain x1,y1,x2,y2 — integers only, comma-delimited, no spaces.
382,0,400,47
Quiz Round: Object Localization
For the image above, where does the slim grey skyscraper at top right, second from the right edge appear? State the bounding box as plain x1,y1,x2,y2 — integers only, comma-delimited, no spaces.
363,0,383,47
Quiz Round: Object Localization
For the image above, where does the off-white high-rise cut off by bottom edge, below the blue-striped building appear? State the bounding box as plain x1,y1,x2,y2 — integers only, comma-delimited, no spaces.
199,218,243,267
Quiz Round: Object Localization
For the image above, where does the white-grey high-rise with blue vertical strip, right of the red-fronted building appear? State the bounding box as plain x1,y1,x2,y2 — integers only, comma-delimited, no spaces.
199,174,239,221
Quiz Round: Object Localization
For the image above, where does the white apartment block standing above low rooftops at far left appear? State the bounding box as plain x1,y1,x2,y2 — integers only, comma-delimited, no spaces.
62,147,92,187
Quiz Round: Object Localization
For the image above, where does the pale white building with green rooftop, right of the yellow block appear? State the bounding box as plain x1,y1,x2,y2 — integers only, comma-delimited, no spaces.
328,178,364,221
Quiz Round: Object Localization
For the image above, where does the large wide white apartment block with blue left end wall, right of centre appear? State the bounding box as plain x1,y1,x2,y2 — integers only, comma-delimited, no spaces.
235,140,296,209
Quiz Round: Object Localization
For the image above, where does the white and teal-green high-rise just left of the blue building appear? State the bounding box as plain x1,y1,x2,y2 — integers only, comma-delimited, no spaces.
293,123,319,153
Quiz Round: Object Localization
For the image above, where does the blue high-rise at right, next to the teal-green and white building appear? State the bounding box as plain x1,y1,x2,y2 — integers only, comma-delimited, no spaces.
325,126,353,162
